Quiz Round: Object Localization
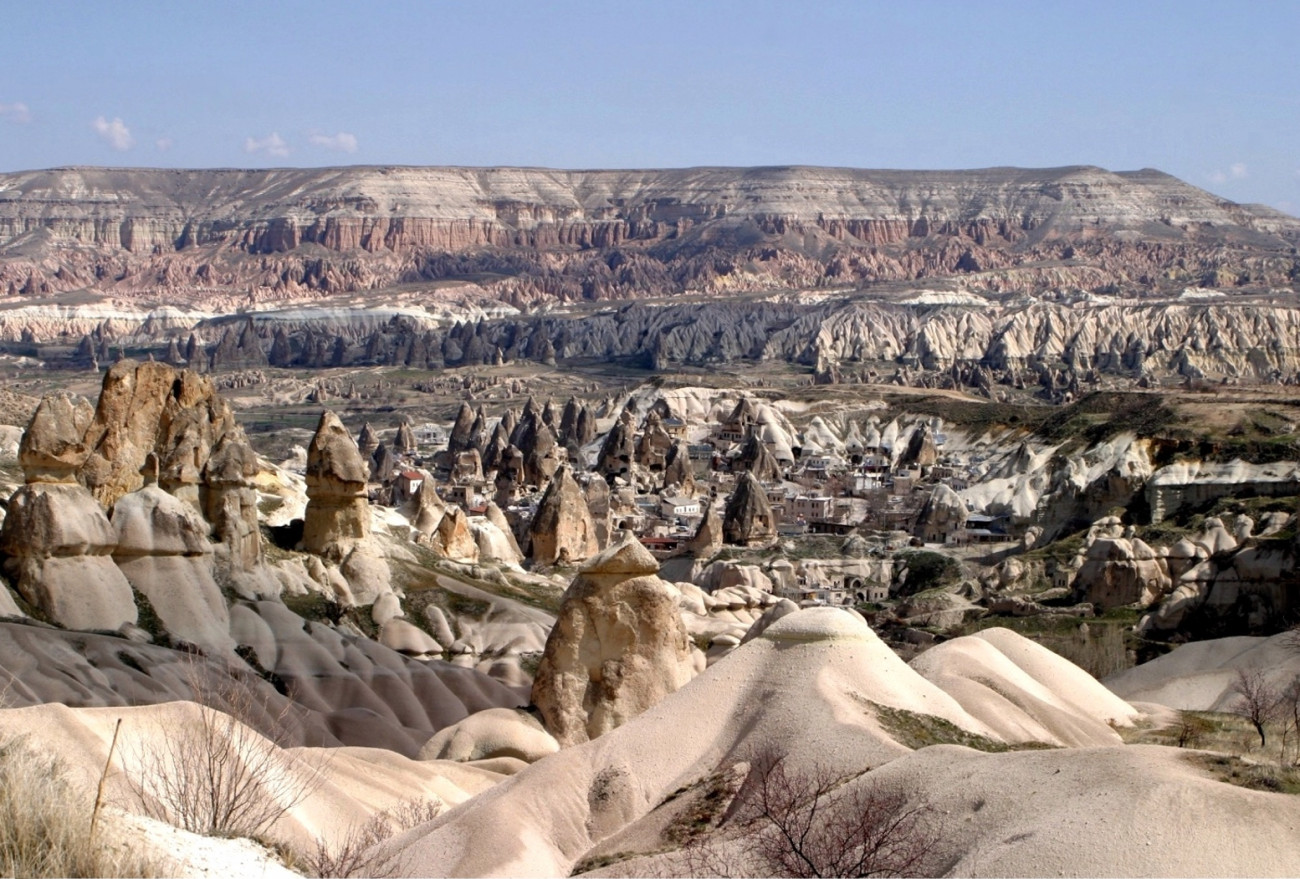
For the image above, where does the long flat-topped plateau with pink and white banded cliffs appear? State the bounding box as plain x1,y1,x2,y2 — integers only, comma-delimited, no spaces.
0,166,1300,306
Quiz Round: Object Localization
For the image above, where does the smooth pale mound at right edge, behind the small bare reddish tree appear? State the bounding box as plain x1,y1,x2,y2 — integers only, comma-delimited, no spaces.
1104,633,1300,711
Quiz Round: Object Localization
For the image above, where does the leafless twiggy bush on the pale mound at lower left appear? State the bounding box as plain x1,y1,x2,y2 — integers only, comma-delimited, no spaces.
124,664,328,837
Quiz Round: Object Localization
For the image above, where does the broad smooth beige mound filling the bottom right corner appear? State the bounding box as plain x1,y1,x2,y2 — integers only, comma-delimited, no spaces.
618,745,1300,876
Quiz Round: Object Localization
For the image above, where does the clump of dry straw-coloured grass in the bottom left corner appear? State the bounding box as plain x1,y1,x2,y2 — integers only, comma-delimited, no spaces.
0,739,169,876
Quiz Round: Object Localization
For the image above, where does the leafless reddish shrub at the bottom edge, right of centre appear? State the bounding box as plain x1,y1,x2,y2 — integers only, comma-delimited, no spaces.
684,754,941,876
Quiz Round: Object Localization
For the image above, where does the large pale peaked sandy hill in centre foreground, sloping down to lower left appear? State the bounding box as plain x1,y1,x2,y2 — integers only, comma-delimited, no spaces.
384,609,1170,875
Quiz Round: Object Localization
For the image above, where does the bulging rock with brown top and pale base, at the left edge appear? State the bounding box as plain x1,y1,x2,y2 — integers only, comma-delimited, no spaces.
0,482,137,631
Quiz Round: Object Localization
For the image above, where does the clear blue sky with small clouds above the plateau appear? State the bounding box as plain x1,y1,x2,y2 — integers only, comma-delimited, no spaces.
0,0,1300,213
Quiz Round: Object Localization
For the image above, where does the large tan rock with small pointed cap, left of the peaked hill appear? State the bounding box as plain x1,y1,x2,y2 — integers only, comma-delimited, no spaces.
533,537,694,745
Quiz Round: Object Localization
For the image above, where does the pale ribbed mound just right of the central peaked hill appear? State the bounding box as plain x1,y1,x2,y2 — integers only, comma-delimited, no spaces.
909,628,1138,748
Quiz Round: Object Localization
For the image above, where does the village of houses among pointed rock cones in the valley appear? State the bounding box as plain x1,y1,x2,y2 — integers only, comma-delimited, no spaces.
325,397,1019,605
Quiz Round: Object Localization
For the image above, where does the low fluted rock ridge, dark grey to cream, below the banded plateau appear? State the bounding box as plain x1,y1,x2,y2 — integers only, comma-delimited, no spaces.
68,294,1300,400
